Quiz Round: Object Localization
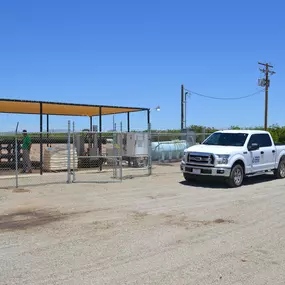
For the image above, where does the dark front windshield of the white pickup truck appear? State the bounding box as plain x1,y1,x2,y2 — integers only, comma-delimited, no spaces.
203,133,248,146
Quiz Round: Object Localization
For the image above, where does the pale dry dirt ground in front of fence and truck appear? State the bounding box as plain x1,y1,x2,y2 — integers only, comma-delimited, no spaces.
0,166,285,285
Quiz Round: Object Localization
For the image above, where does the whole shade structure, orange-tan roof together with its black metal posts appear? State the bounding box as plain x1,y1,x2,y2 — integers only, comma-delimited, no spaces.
0,98,150,175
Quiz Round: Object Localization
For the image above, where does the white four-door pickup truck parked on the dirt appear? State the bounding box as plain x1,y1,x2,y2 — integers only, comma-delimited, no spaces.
180,130,285,187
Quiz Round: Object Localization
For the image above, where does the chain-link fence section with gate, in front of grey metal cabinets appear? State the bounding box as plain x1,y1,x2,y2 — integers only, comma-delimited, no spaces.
71,122,150,182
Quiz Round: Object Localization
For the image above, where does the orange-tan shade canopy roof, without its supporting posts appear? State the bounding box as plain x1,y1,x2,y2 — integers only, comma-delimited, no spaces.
0,98,148,117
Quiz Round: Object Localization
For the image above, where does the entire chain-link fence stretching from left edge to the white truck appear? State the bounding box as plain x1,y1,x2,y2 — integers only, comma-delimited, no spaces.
0,123,213,188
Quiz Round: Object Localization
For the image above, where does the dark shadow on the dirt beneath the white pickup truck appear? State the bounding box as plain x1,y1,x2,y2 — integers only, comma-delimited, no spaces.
179,174,275,189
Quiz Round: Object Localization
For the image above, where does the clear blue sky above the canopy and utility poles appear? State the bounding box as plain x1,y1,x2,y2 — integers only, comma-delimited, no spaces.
0,0,285,131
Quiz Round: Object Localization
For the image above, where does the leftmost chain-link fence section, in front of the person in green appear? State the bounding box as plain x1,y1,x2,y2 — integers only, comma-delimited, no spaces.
0,126,70,188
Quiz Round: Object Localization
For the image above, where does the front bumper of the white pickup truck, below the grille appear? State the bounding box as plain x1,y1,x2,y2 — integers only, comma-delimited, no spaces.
180,162,231,177
